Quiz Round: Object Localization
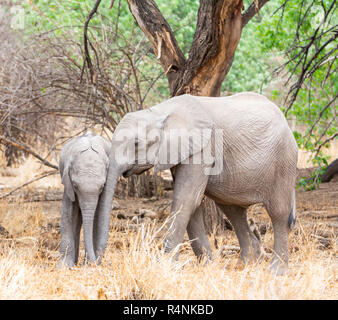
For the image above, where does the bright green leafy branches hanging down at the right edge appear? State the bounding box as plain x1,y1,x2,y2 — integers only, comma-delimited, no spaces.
257,0,338,189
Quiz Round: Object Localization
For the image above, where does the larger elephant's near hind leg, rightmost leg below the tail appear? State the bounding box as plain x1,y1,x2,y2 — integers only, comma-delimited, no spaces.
266,192,294,275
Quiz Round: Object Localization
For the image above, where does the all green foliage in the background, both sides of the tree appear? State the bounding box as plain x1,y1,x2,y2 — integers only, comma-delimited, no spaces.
19,0,338,188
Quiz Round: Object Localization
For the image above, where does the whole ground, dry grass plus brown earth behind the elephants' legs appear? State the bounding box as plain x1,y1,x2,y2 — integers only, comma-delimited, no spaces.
0,162,338,299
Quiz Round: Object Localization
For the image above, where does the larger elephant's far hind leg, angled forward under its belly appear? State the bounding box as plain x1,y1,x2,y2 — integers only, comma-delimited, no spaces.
218,204,263,263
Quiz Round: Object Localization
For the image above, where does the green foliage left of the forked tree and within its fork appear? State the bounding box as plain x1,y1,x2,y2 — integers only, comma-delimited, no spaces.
23,0,203,104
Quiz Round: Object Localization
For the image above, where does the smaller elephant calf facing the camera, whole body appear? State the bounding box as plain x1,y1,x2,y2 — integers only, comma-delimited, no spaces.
59,132,110,268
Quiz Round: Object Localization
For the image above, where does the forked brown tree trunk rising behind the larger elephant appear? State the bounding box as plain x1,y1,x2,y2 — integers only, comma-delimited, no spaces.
128,0,268,233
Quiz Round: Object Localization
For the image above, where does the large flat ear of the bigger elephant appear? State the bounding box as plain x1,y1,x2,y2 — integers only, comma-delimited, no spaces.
154,95,213,171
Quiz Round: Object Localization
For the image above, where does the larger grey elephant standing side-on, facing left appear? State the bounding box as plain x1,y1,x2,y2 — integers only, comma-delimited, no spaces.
98,92,298,273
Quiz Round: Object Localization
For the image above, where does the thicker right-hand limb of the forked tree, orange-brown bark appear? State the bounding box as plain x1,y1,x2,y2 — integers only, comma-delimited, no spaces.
175,0,243,96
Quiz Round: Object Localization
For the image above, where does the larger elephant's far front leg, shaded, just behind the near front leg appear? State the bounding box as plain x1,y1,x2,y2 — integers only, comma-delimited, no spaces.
187,206,212,260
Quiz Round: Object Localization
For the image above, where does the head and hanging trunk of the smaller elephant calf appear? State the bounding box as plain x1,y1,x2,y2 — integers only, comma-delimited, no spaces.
60,134,109,261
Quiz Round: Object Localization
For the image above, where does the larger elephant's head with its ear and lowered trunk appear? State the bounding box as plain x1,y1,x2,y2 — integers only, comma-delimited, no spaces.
93,95,213,255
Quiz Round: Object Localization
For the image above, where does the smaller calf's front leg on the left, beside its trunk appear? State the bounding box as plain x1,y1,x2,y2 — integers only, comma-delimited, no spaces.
58,194,82,268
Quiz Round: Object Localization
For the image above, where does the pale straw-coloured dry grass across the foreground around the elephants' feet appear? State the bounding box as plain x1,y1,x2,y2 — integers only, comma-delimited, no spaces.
0,201,338,299
